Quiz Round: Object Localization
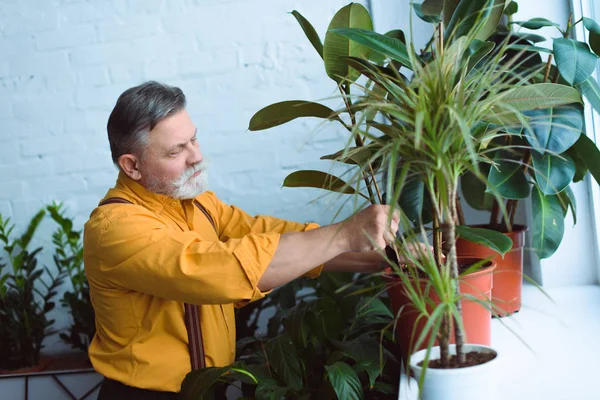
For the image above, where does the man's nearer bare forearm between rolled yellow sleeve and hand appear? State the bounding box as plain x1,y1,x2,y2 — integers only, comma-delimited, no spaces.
258,224,350,291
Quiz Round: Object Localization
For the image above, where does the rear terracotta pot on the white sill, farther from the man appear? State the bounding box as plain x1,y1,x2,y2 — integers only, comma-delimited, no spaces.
456,225,527,317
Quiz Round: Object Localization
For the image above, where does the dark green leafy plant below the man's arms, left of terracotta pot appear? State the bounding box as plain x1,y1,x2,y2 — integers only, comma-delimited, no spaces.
182,274,400,399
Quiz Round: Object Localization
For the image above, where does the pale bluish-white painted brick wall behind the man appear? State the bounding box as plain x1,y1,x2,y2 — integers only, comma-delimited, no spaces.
0,0,366,352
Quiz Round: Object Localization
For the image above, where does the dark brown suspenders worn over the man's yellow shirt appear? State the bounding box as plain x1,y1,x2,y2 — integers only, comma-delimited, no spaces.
99,197,217,371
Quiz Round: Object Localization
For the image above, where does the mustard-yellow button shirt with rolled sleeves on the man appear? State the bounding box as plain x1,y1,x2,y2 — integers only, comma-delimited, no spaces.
84,173,320,392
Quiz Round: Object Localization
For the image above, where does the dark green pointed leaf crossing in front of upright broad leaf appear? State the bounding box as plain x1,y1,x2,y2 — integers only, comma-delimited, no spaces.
330,28,411,68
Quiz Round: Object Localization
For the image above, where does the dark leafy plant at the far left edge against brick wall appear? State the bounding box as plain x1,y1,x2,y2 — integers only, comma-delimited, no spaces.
0,210,64,371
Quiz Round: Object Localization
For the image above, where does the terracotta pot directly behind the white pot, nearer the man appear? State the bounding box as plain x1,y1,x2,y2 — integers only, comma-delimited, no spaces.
384,257,496,361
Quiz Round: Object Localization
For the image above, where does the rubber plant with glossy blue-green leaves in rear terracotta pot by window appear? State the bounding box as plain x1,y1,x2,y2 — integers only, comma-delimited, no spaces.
450,2,600,316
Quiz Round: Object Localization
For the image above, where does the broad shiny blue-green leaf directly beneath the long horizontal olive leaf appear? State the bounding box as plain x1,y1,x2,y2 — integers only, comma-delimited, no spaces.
525,106,583,154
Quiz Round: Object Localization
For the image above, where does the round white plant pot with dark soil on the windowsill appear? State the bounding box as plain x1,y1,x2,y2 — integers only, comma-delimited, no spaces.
410,344,502,400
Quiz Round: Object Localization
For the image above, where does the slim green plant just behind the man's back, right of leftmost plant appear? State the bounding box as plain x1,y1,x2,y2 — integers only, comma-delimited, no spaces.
47,203,96,351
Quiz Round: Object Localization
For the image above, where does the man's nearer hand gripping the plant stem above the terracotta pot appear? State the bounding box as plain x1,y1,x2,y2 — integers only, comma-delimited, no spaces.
339,204,400,252
